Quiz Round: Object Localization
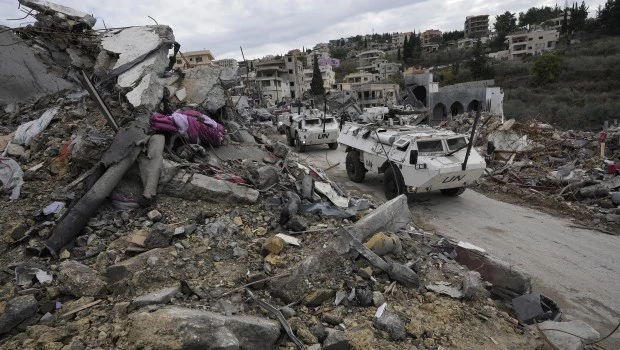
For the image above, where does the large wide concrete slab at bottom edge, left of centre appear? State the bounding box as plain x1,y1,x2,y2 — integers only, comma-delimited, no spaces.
128,307,280,350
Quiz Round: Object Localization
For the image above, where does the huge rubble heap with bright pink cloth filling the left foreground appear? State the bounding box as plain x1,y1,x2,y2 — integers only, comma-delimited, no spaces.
0,0,599,350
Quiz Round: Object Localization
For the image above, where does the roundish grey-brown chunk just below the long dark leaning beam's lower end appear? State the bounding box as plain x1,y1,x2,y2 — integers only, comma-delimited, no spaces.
58,260,106,297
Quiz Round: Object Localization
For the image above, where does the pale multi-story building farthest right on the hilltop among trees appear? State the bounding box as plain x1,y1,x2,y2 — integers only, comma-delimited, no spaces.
506,30,560,60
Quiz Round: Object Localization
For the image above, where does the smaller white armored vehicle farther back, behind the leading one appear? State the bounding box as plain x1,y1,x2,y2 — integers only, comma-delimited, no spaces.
278,106,338,152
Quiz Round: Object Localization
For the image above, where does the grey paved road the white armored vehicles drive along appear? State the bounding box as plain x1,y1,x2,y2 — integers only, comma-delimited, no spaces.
290,142,620,349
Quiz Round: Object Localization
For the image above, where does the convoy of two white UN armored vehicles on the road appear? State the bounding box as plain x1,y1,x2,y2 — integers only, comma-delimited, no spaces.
264,105,486,199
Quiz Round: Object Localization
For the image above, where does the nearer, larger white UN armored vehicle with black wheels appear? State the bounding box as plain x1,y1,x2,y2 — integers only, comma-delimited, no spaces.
338,111,486,199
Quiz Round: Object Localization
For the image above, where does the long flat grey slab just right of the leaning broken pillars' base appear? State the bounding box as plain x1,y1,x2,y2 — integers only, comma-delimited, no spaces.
159,161,259,203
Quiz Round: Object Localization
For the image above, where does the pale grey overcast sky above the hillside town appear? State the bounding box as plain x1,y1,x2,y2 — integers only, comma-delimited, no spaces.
0,0,605,59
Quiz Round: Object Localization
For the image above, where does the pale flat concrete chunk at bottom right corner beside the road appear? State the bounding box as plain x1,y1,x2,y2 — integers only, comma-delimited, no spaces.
538,320,601,350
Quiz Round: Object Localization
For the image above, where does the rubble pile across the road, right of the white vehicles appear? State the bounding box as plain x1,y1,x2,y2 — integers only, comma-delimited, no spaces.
445,113,620,234
